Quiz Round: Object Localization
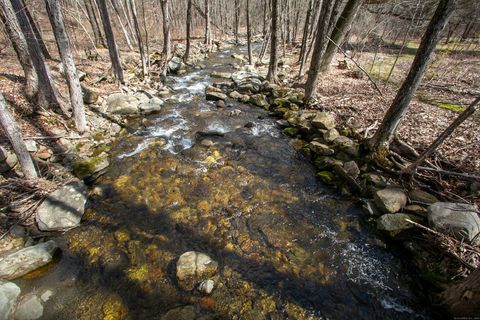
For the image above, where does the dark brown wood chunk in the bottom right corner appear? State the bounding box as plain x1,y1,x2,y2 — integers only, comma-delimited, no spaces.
440,269,480,319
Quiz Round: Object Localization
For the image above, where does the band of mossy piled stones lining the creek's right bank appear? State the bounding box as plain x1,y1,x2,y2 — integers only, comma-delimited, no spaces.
210,65,480,304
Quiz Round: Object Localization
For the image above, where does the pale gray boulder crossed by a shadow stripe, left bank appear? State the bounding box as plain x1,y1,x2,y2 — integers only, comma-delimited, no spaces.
36,182,87,231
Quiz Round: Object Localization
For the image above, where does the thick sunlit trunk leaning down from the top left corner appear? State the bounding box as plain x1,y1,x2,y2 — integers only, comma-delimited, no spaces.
0,0,38,100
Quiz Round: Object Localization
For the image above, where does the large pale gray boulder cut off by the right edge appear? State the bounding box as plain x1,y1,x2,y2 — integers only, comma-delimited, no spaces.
428,202,480,245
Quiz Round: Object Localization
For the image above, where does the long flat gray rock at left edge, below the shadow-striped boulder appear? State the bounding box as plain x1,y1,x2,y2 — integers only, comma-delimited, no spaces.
0,240,58,280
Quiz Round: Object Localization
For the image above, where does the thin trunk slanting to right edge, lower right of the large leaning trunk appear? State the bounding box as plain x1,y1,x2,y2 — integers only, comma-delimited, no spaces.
405,97,480,175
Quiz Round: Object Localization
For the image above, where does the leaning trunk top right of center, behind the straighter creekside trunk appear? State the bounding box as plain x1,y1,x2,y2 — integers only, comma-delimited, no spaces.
320,0,363,72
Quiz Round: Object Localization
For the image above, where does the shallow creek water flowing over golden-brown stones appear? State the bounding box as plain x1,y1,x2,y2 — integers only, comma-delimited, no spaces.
17,46,429,319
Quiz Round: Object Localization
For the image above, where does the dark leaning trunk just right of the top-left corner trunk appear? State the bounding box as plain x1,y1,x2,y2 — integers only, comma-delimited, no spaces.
9,0,61,112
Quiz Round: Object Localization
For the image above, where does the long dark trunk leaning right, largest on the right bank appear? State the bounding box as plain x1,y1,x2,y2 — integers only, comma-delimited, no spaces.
370,0,456,155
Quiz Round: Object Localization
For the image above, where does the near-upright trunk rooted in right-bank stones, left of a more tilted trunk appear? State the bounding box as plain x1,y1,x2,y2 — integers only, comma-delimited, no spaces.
305,0,335,101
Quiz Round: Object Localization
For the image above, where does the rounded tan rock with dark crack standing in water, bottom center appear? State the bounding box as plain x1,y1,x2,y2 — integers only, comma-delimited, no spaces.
177,251,218,290
